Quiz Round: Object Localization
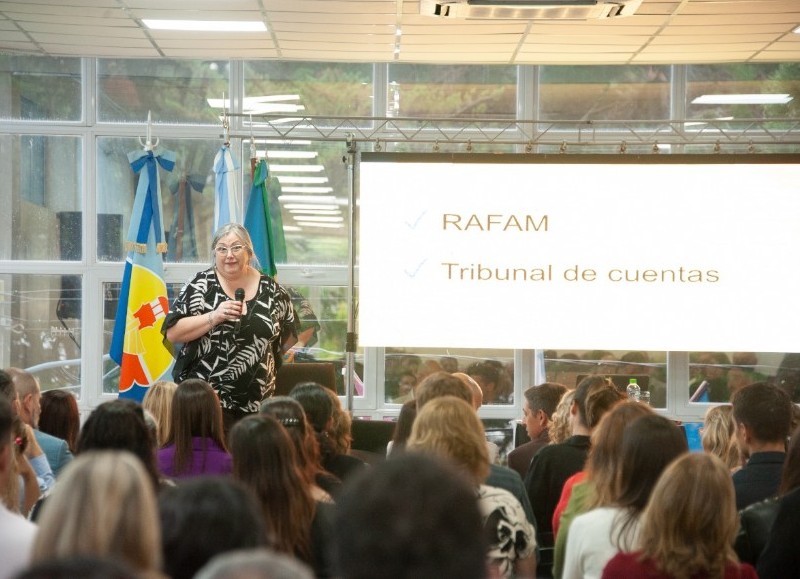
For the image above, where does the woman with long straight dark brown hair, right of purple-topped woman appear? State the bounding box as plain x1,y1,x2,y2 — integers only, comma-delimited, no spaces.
230,414,333,577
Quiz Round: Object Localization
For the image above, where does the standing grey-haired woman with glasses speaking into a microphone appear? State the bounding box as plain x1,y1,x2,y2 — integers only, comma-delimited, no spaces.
162,223,297,431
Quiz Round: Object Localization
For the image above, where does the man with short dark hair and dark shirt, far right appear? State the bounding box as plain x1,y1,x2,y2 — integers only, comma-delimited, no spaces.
733,382,792,510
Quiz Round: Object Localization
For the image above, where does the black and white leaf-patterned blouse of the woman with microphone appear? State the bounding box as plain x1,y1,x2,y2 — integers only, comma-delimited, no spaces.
162,268,295,413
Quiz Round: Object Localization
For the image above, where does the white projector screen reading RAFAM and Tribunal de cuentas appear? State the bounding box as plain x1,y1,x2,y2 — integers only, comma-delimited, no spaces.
359,153,800,352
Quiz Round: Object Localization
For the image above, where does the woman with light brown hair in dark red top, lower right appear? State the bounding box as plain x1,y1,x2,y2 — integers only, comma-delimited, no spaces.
602,453,756,579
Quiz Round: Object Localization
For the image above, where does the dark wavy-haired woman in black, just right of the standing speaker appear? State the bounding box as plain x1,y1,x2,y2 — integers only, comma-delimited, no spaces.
289,382,366,481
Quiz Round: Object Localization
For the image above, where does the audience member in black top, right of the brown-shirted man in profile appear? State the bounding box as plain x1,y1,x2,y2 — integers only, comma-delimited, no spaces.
525,375,623,574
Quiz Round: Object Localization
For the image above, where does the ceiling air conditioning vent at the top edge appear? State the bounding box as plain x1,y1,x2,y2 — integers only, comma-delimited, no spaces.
420,0,643,20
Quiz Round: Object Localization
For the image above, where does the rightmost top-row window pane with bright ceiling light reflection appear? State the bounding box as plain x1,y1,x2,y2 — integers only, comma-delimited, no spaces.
686,62,800,122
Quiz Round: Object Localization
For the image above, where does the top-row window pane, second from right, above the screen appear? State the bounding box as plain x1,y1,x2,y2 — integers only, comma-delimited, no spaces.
539,65,670,121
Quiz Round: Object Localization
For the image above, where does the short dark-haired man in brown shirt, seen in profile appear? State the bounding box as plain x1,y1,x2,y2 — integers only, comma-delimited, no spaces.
508,382,567,478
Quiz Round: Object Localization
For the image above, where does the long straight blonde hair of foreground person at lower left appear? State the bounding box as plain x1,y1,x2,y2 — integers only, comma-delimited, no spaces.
32,451,161,573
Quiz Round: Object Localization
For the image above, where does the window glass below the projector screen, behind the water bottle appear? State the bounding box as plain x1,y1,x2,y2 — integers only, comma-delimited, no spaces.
544,350,667,408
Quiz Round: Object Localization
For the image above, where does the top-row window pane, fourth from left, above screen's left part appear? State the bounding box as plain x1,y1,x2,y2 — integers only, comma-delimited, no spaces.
386,64,517,120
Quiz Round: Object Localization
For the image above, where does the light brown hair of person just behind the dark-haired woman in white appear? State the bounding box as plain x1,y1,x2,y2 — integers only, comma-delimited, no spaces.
586,401,654,508
